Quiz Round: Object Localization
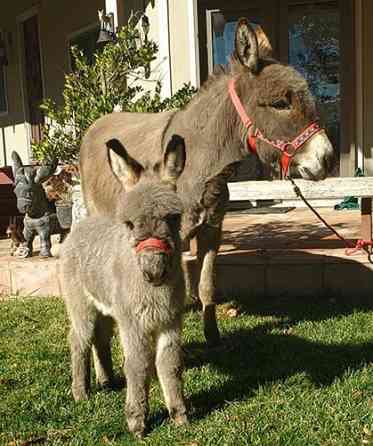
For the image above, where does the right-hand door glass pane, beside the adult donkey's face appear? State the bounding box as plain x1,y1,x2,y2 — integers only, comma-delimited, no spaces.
289,1,341,175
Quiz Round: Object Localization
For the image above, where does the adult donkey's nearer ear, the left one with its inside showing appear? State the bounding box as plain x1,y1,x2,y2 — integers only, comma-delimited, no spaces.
234,18,259,74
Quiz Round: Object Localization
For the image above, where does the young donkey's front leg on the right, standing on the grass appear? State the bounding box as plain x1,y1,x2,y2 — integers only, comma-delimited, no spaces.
155,324,188,425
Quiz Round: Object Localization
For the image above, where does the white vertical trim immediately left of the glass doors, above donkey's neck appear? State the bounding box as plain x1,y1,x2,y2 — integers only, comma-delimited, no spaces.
188,0,201,88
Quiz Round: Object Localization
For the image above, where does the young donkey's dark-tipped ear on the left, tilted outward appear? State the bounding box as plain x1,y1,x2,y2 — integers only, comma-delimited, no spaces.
106,138,144,190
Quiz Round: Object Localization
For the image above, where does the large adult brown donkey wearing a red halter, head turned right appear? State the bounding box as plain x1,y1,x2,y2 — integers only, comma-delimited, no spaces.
80,19,333,344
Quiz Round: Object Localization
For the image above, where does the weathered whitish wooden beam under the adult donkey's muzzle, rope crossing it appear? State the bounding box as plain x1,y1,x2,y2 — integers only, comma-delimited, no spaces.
228,177,373,201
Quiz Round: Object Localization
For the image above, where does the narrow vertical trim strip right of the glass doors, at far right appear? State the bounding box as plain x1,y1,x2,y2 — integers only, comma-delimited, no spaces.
355,0,364,170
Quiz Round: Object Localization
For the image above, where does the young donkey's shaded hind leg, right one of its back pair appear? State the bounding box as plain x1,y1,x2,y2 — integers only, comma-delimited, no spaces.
93,314,114,387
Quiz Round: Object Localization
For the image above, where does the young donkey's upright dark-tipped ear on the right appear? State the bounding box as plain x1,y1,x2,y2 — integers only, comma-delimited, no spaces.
161,135,186,186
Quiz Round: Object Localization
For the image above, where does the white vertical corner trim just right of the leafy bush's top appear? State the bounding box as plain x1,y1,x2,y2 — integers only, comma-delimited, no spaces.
158,0,172,97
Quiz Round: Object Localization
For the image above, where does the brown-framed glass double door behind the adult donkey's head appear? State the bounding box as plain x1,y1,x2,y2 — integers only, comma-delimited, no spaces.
198,0,356,176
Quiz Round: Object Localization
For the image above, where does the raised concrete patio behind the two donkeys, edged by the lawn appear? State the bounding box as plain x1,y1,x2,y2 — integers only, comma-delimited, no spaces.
0,208,373,298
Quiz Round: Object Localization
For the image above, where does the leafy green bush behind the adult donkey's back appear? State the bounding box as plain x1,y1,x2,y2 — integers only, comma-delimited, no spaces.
32,14,196,164
